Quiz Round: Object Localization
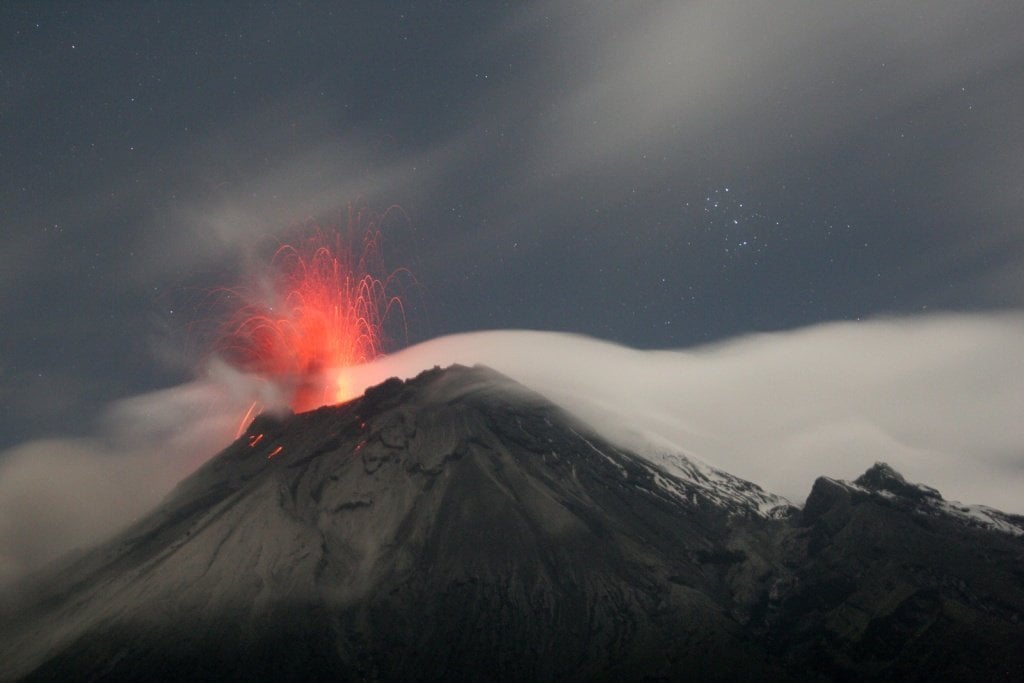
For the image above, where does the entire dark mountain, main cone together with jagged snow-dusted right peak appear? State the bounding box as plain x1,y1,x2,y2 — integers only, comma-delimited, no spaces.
0,366,1024,680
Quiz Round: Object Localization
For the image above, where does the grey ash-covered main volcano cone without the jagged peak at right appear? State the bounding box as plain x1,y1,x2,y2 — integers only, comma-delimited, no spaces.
0,367,772,680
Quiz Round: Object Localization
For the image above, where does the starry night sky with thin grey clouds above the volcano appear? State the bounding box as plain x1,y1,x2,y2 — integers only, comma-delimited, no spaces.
0,0,1024,446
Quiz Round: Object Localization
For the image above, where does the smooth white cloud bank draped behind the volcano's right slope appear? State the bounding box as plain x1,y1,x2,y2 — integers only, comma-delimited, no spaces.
352,313,1024,513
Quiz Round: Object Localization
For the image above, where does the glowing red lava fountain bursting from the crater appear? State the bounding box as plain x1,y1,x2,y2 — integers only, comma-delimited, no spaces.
214,209,412,413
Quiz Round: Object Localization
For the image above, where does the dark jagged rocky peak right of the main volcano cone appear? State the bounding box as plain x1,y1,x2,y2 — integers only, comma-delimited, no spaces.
770,463,1024,680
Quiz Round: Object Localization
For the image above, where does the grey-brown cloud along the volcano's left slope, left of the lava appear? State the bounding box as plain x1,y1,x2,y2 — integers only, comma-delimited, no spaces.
0,361,268,587
